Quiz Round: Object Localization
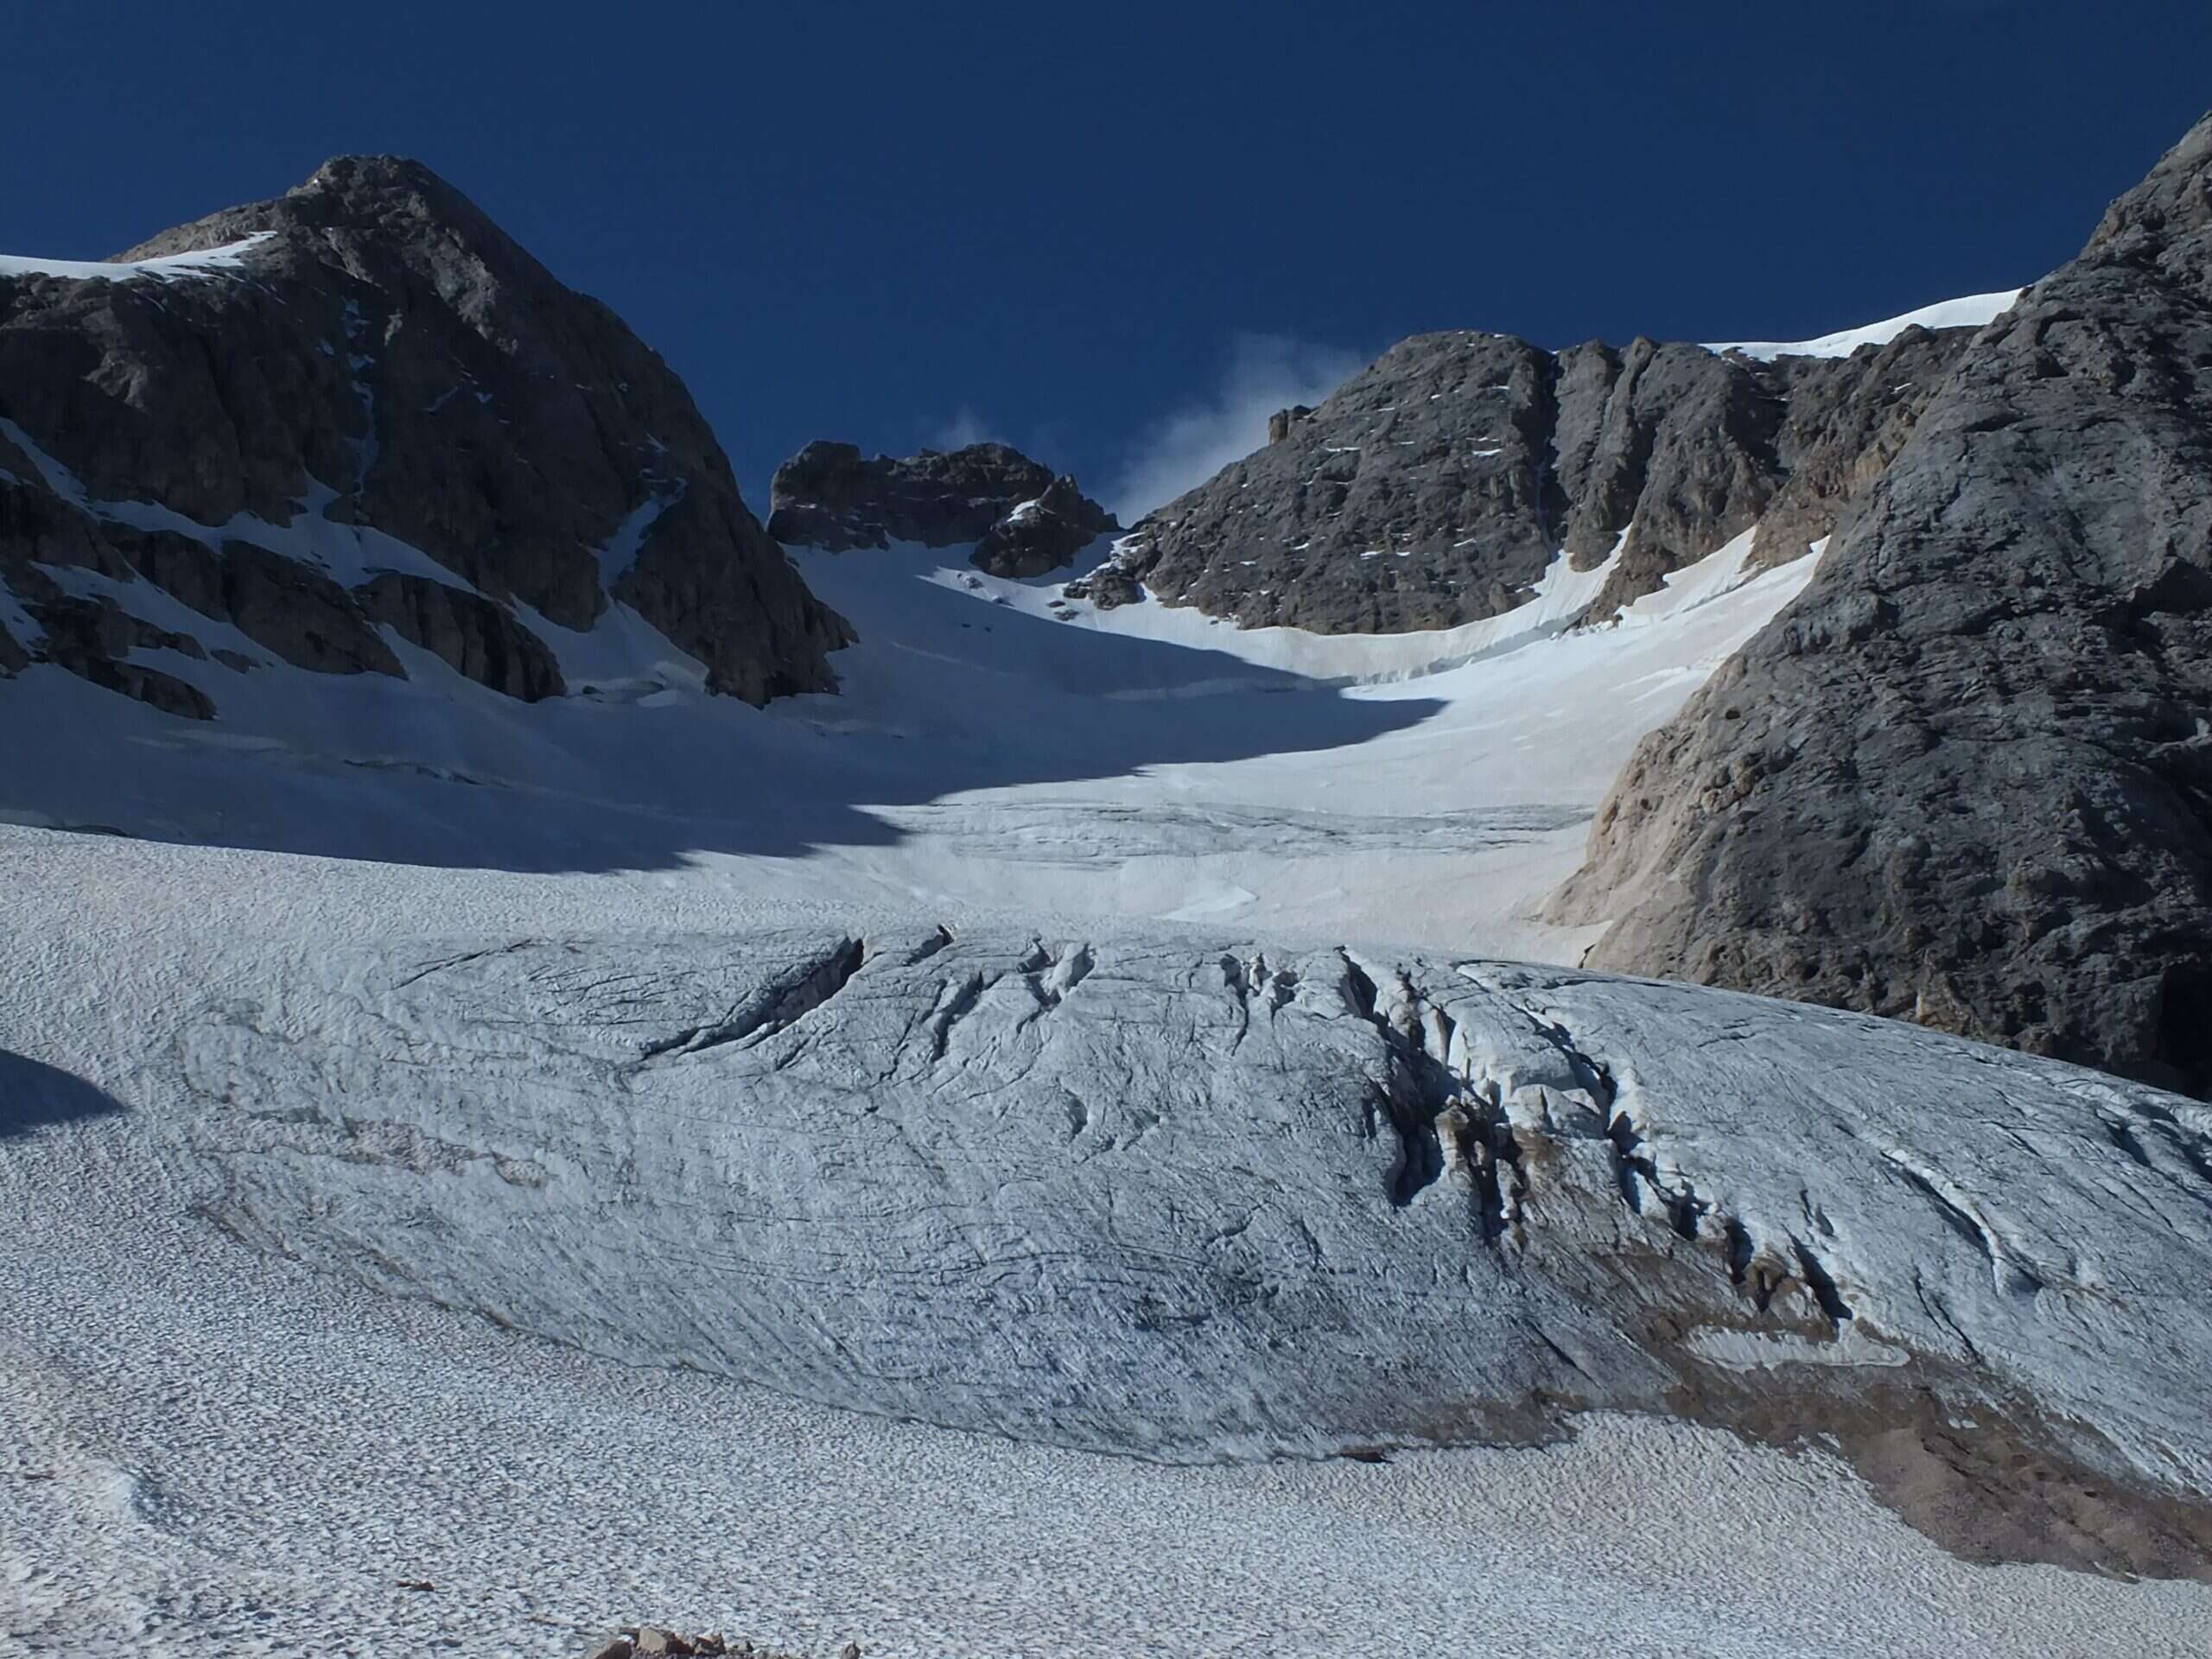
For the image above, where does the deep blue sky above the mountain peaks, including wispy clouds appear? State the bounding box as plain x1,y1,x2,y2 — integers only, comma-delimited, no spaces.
0,0,2212,509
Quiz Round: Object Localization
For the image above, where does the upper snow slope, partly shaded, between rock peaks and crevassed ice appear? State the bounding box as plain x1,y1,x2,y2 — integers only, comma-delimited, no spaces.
0,506,1812,957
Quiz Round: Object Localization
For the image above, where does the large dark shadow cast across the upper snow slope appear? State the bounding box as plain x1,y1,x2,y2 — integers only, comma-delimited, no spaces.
0,553,1442,872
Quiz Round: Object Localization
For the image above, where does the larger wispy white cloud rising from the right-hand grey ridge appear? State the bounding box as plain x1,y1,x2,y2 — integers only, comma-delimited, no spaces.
1106,334,1367,524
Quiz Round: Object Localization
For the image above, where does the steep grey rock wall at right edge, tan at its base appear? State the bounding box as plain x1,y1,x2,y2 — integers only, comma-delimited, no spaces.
1553,119,2212,1095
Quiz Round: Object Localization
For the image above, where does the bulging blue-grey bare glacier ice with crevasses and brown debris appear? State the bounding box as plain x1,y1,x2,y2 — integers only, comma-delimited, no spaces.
186,927,2212,1573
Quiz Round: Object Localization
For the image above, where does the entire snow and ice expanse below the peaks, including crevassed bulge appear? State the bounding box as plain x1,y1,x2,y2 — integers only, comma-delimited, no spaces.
0,512,2212,1659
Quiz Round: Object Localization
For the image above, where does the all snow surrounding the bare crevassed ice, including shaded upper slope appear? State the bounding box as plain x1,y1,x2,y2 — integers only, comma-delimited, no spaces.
0,522,2212,1659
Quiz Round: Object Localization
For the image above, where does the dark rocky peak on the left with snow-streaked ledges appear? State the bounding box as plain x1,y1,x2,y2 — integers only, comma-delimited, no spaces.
0,157,849,712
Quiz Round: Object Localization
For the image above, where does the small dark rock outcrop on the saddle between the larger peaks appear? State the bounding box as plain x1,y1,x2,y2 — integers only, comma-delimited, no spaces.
767,442,1117,577
